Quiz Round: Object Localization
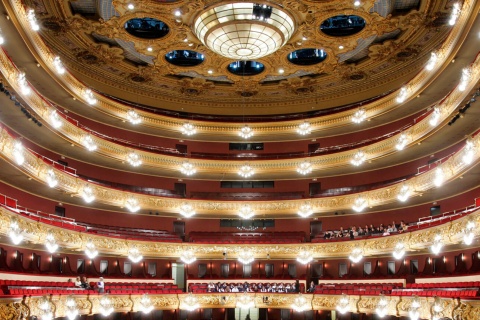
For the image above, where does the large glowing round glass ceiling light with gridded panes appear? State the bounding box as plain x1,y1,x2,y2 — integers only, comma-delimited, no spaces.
193,2,295,60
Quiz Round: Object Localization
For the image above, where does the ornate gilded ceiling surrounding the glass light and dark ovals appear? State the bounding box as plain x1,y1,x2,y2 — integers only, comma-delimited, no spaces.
25,0,453,116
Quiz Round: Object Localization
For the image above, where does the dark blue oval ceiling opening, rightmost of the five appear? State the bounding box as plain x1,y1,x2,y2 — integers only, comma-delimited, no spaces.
320,15,366,37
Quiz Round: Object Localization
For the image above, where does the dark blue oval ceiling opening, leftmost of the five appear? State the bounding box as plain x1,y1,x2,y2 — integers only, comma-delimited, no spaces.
124,18,170,39
